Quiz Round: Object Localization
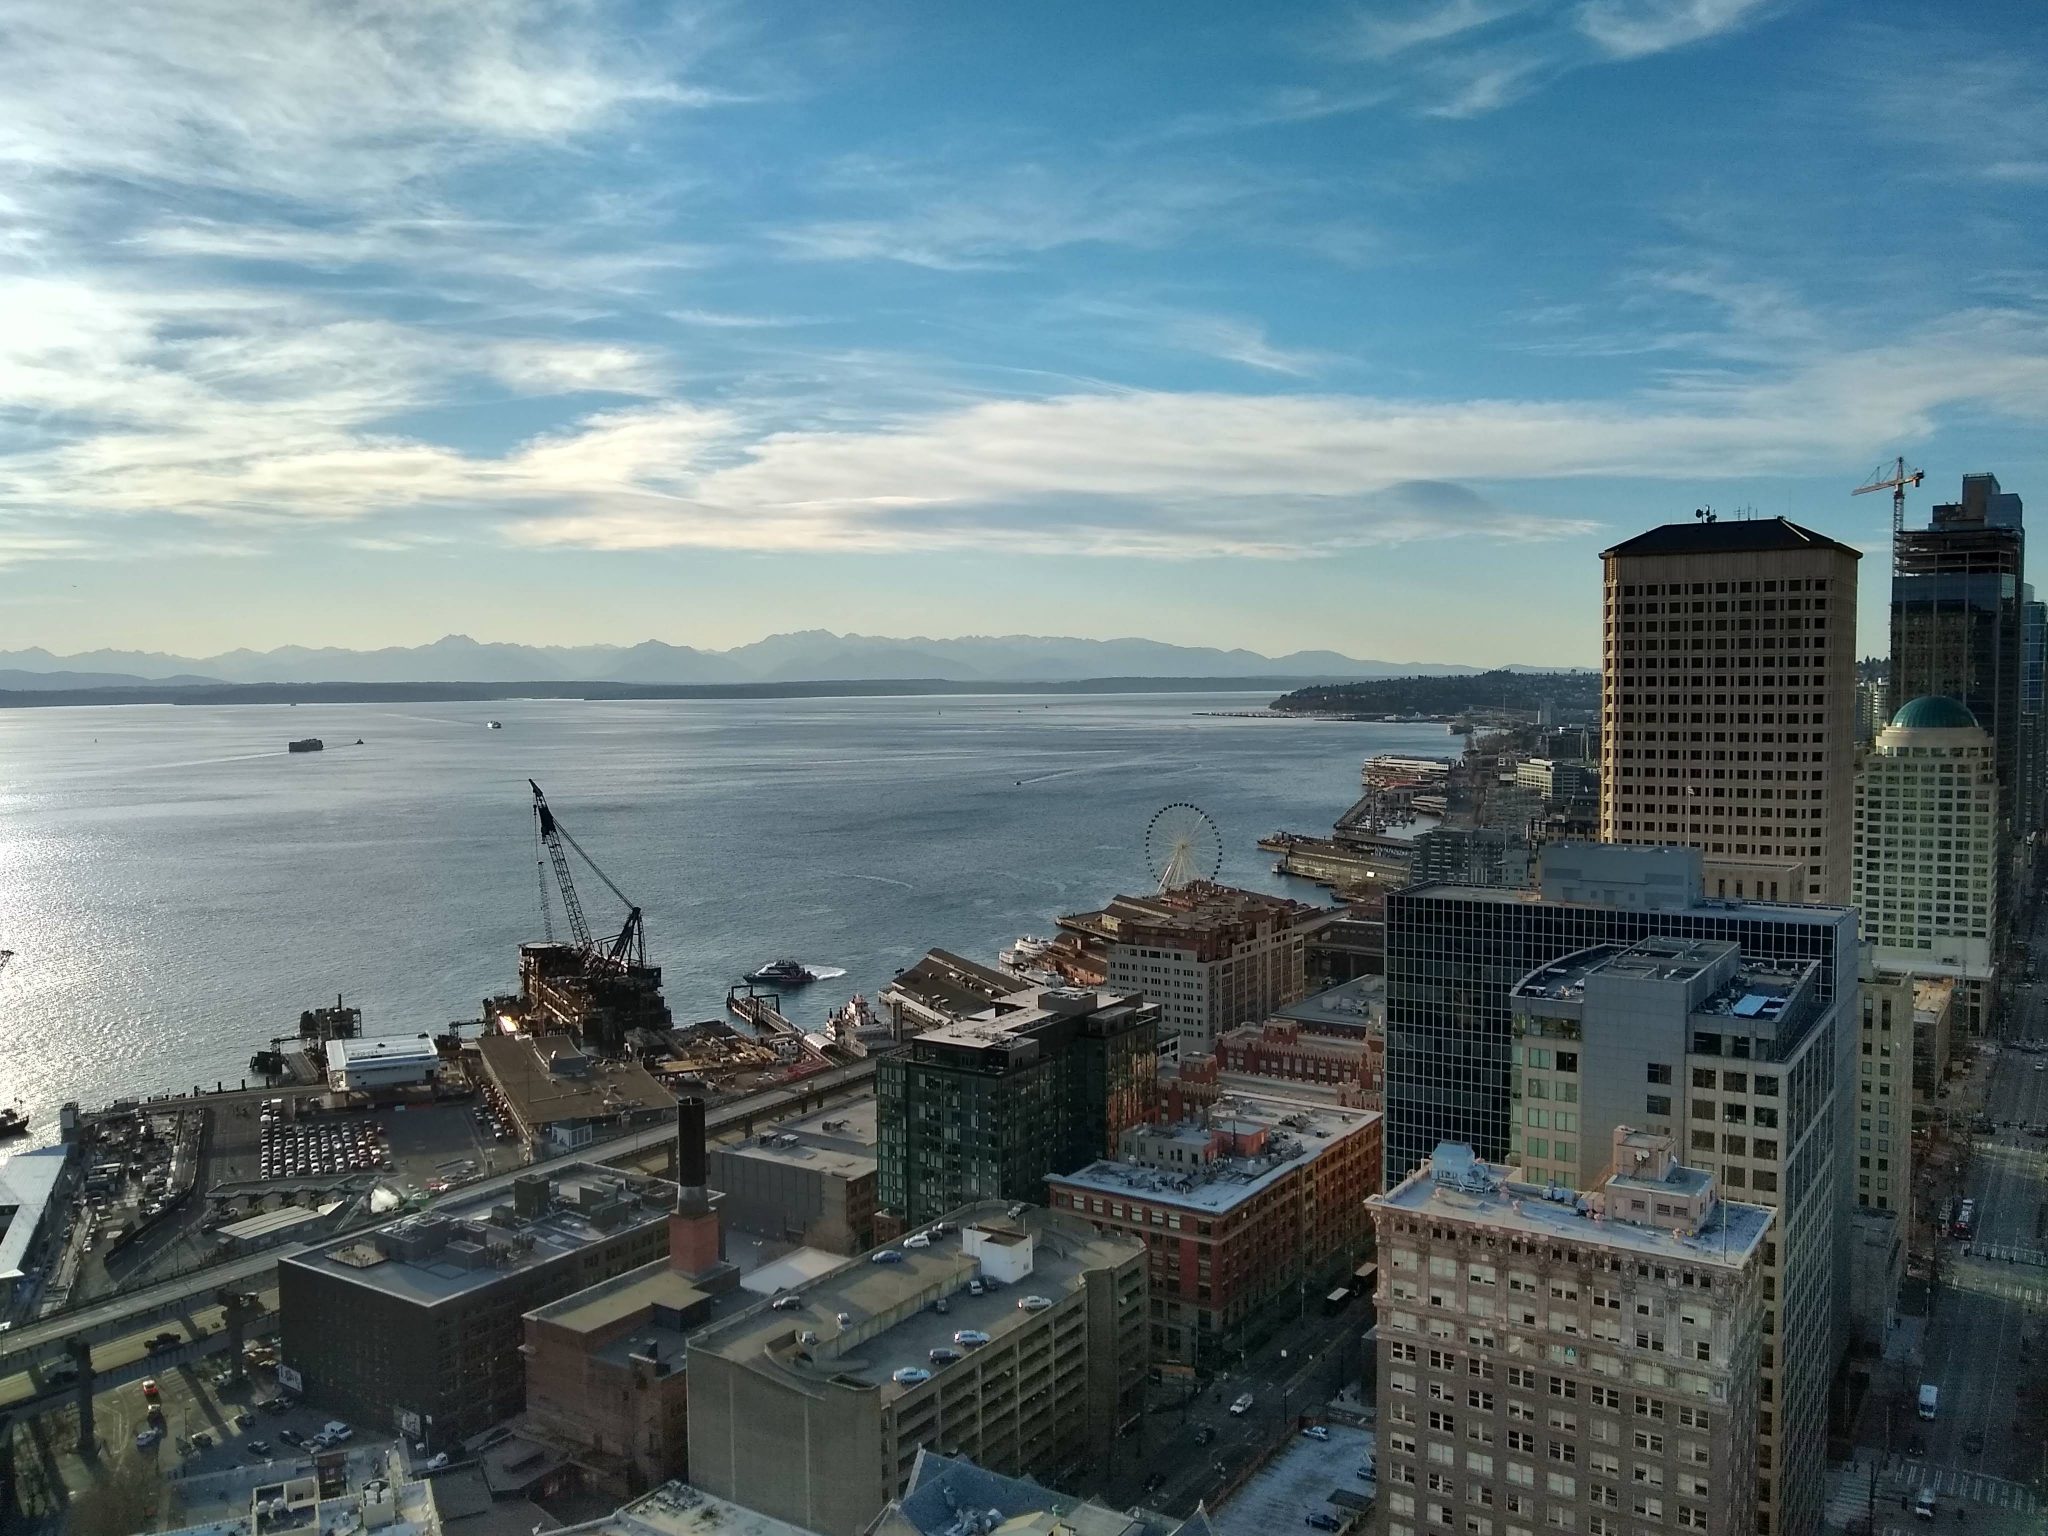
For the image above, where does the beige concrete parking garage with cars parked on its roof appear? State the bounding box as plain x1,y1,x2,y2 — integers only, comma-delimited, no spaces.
688,1202,1147,1536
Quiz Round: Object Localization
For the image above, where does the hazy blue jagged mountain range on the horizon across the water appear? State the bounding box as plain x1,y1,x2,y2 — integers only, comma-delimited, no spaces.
0,629,1572,690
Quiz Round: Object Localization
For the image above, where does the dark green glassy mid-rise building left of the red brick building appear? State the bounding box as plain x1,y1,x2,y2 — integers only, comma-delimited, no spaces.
874,987,1159,1227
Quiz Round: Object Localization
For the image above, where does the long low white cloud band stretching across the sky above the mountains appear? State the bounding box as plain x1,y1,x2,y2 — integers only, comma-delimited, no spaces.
12,288,2048,559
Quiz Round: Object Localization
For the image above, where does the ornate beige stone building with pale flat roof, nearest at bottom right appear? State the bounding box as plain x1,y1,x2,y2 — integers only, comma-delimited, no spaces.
1372,1128,1772,1536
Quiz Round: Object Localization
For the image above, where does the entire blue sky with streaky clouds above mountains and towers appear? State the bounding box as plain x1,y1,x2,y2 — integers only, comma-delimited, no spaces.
0,0,2048,666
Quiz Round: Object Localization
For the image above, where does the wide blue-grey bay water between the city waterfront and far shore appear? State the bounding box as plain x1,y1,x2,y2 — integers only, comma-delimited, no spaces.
0,694,1460,1139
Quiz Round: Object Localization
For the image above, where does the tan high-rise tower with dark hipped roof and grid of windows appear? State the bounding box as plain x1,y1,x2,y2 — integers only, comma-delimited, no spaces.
1599,518,1862,905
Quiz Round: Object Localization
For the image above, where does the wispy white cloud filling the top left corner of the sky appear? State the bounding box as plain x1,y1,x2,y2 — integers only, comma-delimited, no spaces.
0,0,721,205
